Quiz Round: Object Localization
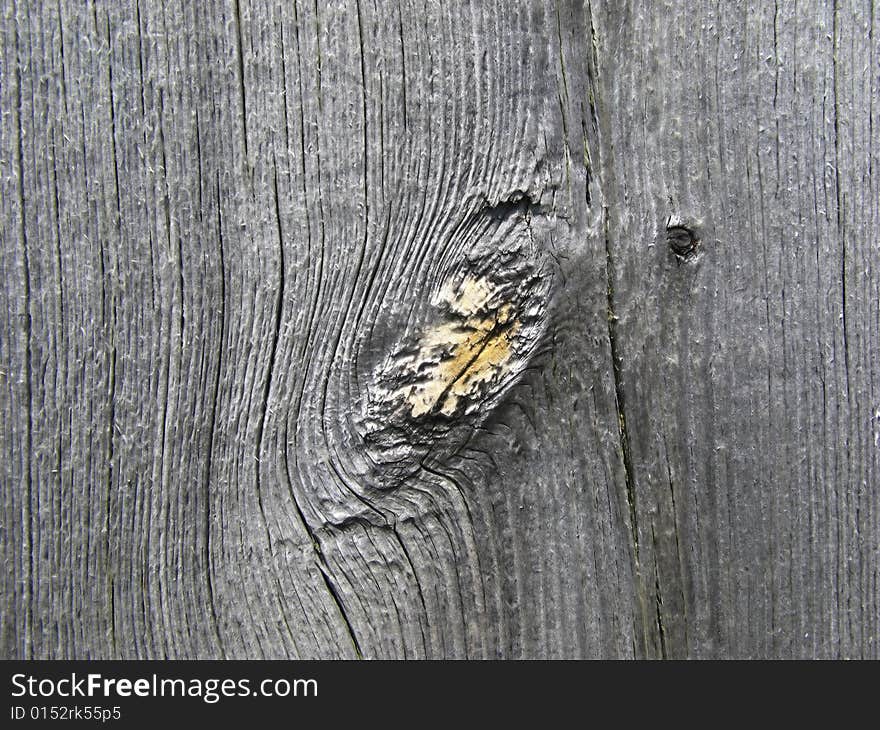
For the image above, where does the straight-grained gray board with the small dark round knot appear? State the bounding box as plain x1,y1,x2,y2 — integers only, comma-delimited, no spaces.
595,2,880,658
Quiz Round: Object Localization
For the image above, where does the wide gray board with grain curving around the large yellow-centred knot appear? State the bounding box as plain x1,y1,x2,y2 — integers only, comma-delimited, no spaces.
3,3,631,657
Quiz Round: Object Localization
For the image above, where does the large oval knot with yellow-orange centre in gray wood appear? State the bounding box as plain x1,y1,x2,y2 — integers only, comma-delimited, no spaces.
356,196,553,489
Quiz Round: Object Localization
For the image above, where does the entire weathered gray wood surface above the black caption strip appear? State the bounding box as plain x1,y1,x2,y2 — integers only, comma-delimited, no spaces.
0,0,880,658
